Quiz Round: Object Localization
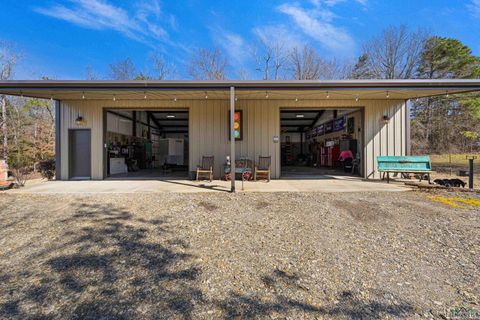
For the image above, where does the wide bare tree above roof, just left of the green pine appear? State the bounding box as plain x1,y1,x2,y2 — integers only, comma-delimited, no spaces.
359,25,428,79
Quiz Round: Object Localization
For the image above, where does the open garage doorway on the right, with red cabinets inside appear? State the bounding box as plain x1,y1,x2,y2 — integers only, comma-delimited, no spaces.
280,108,363,177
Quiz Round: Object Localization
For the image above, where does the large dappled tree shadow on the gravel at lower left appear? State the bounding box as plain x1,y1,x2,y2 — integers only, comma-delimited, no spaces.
0,202,204,319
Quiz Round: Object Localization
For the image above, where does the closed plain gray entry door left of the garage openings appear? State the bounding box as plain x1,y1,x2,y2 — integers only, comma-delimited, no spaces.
68,129,92,179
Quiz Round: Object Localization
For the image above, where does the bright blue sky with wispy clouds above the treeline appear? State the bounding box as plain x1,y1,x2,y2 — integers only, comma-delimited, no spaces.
0,0,480,79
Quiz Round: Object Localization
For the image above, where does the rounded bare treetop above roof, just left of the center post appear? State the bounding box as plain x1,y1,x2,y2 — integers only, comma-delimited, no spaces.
188,48,227,80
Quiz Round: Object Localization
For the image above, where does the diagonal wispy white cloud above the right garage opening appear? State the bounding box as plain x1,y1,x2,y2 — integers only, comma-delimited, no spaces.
277,0,355,53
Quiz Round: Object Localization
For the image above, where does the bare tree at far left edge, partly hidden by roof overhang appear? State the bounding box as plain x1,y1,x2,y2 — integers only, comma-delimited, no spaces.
0,43,18,159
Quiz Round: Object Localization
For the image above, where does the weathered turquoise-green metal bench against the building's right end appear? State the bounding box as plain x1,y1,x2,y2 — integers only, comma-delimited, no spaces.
377,156,432,183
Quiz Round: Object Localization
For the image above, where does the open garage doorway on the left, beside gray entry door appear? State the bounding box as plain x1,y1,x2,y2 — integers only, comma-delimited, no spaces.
105,109,189,179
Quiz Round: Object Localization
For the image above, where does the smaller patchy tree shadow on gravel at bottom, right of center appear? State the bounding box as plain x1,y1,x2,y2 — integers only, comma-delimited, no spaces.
215,269,413,319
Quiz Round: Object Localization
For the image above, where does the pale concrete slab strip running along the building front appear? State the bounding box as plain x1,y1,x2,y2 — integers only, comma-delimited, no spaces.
6,176,411,194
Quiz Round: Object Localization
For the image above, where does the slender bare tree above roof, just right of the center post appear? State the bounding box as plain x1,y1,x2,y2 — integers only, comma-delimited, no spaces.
252,35,288,80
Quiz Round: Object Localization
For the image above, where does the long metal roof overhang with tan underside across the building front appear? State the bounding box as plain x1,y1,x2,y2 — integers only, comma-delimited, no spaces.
0,79,480,100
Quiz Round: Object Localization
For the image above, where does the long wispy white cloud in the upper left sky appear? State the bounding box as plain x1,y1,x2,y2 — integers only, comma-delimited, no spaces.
35,0,168,43
